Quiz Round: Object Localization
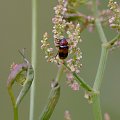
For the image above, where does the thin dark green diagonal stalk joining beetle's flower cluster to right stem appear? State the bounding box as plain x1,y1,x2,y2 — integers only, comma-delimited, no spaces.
63,63,93,91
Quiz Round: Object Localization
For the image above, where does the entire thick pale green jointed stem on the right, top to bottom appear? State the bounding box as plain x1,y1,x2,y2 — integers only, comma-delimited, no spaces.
92,0,108,120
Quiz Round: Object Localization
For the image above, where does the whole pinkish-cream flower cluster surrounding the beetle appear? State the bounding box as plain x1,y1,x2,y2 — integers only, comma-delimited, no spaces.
41,0,82,90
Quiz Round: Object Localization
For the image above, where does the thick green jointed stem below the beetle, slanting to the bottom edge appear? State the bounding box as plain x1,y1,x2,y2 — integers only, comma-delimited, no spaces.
39,65,64,120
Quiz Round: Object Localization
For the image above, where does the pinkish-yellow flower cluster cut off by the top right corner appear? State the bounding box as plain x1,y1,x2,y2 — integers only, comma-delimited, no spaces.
108,0,120,32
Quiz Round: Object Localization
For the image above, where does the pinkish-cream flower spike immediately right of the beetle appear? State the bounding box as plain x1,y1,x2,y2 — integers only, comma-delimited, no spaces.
67,23,82,73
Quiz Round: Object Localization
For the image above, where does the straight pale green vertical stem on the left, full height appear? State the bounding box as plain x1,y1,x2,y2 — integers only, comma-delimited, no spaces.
29,0,37,120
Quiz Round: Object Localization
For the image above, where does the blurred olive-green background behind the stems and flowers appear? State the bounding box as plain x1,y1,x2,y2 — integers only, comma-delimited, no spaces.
0,0,120,120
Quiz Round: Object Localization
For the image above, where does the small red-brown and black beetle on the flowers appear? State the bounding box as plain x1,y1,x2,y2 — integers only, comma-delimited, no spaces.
58,38,69,59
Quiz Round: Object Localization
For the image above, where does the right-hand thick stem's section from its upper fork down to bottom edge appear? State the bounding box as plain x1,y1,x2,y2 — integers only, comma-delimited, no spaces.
93,45,108,120
